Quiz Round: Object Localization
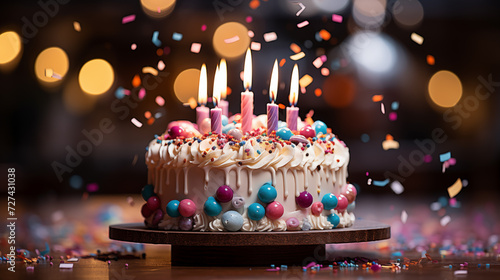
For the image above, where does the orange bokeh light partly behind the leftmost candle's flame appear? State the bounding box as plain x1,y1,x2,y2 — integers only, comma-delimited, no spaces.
174,68,200,103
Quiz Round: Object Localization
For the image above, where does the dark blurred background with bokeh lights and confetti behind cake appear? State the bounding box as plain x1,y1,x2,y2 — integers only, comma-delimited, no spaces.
0,0,500,254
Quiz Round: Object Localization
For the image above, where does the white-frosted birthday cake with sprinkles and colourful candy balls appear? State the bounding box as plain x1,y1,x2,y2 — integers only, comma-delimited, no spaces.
141,115,357,231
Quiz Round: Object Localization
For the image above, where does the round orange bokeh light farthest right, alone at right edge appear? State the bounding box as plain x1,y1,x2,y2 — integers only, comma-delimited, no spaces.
429,70,462,108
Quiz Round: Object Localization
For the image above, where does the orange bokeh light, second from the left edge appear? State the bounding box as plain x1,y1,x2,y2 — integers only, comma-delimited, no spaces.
35,47,69,85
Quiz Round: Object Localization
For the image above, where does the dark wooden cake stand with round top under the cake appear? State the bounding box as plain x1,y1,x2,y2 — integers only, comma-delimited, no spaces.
109,220,391,266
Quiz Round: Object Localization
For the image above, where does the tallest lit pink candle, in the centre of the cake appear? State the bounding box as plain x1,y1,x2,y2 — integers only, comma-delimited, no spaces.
241,49,253,133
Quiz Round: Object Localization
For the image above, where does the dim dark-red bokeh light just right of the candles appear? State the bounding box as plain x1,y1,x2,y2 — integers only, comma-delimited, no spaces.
322,74,356,108
